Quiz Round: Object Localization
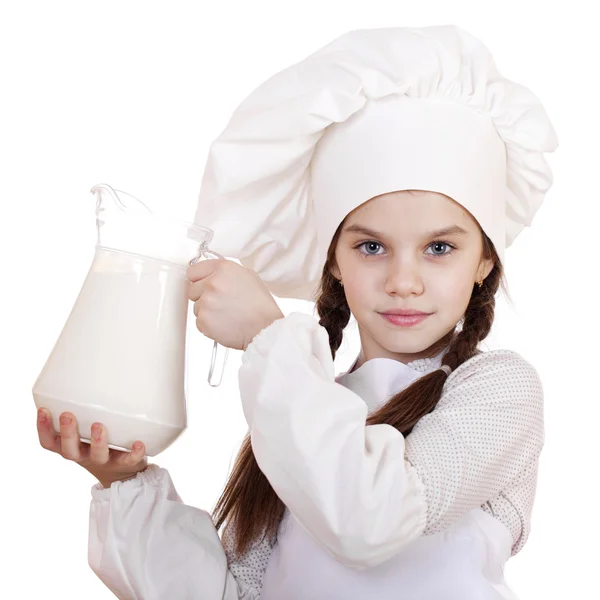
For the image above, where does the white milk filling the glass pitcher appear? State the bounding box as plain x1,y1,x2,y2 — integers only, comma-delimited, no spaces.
33,247,190,456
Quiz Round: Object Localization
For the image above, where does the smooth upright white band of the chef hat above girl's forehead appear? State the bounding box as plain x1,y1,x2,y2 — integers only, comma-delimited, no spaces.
310,95,506,264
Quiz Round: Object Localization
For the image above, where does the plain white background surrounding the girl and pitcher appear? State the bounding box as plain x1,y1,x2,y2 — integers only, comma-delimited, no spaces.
0,0,600,600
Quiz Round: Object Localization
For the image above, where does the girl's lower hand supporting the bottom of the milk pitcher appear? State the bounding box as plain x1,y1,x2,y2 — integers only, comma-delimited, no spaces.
37,408,148,488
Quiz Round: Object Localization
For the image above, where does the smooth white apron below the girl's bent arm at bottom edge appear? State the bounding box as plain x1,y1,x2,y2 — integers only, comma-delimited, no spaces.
261,509,517,600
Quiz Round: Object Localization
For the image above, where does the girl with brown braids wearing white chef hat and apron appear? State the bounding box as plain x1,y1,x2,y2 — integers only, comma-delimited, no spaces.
35,25,558,600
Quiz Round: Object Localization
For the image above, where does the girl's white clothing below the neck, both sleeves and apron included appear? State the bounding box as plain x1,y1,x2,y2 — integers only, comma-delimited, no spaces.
89,313,544,600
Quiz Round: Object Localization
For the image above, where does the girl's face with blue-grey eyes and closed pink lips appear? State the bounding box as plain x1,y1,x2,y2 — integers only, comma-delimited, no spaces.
332,190,494,368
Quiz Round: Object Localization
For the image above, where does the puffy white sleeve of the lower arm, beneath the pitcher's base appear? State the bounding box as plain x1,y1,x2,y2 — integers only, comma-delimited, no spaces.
88,464,260,600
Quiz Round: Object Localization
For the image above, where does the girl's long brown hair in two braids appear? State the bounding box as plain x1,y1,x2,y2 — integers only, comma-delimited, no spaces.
212,214,507,556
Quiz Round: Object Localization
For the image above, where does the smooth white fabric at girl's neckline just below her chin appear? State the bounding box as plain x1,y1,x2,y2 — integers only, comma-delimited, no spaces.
335,348,446,413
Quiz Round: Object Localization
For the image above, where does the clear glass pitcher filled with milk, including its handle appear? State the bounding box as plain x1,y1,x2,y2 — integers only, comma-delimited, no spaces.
32,184,229,456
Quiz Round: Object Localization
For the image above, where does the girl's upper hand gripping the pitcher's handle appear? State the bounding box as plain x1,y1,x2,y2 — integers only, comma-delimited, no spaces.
187,259,283,350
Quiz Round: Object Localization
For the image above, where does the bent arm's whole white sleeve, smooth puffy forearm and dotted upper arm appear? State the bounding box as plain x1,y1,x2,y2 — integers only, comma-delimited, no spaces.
239,313,543,569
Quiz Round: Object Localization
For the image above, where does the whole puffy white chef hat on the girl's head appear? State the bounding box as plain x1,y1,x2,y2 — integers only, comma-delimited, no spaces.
195,25,558,300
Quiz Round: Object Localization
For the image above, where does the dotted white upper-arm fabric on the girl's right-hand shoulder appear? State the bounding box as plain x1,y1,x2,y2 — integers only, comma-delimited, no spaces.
405,350,544,554
